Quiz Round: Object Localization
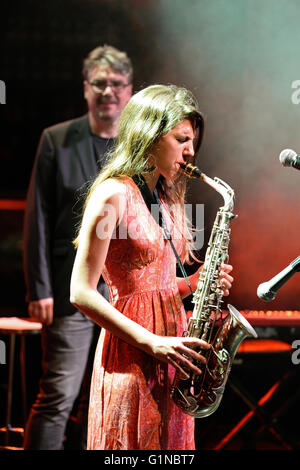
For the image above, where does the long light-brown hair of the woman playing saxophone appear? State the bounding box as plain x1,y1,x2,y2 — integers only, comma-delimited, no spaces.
74,85,204,261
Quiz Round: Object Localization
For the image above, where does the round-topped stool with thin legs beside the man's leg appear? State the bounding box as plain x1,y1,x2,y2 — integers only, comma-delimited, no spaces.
0,317,42,449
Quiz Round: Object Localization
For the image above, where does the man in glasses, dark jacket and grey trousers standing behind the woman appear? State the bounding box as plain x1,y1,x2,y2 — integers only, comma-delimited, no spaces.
24,45,133,450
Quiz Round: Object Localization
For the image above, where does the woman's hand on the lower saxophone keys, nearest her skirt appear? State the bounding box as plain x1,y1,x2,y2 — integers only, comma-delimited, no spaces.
150,335,211,378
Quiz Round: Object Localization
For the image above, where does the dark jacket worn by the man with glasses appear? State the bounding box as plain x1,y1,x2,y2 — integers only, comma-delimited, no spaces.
24,115,98,316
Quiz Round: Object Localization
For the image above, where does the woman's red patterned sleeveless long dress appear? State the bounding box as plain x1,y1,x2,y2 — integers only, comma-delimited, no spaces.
88,177,195,450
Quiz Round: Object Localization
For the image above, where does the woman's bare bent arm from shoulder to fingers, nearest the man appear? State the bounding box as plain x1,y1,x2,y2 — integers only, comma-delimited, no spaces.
70,180,210,376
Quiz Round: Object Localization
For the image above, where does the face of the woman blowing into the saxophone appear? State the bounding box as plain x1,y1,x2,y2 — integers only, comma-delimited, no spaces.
151,119,194,180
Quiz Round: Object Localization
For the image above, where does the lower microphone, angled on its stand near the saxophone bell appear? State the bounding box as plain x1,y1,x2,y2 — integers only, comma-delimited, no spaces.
257,256,300,302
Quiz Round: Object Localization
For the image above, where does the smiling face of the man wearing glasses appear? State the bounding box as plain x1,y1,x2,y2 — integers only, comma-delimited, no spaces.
84,66,132,122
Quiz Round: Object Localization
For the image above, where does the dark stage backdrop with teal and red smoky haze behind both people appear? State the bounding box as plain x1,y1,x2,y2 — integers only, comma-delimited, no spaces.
0,0,300,450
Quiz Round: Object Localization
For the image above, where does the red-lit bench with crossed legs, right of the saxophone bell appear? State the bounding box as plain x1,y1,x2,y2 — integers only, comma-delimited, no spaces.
214,339,299,450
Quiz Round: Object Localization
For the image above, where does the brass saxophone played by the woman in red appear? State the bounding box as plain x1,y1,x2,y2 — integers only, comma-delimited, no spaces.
171,164,257,418
